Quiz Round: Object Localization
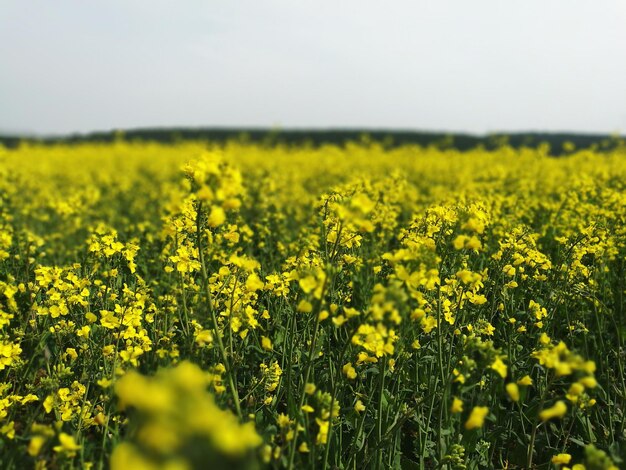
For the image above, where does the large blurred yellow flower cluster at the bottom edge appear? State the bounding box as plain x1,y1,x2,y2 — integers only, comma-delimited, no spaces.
111,362,262,470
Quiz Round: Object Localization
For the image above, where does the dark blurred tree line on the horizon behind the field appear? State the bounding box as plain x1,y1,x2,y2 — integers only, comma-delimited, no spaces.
0,128,626,155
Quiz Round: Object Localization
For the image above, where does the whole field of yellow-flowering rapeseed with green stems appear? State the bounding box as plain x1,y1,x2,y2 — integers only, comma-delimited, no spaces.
0,142,626,470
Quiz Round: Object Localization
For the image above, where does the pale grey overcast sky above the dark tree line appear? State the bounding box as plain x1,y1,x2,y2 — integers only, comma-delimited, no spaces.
0,0,626,134
